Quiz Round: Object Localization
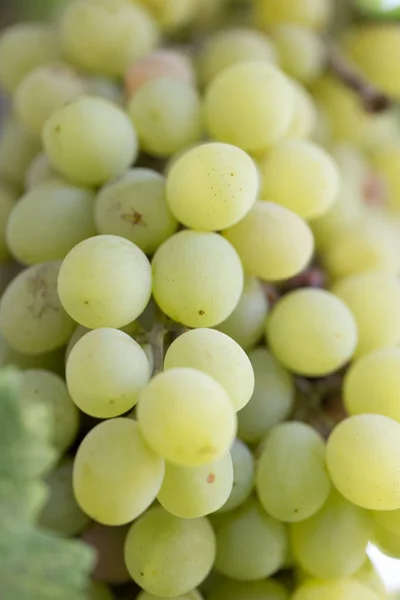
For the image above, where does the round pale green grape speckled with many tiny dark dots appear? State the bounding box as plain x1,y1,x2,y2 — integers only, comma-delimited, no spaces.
167,143,259,231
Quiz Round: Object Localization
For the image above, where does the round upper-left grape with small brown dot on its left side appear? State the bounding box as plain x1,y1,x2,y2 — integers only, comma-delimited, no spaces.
43,96,138,185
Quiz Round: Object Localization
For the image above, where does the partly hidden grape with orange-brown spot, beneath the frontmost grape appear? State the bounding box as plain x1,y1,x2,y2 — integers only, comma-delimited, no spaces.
157,452,233,519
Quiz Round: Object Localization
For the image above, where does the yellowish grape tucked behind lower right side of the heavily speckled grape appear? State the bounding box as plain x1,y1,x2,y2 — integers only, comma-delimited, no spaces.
224,202,314,281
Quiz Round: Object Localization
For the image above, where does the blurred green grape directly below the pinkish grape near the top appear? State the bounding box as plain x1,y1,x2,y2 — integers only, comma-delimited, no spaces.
128,77,202,157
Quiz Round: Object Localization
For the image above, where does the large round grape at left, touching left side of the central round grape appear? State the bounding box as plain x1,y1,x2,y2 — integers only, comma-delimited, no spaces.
58,235,151,329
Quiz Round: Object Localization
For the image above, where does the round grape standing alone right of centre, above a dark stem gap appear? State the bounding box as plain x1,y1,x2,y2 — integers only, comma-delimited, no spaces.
266,288,357,377
